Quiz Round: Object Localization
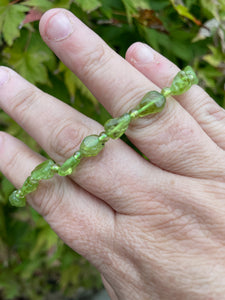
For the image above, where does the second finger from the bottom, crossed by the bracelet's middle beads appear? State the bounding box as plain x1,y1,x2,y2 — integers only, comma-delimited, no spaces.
0,68,158,213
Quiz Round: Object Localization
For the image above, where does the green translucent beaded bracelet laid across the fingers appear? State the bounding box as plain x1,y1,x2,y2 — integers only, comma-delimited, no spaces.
9,66,198,207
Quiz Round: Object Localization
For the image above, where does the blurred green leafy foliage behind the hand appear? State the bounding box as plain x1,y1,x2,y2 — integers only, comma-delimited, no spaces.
0,0,225,300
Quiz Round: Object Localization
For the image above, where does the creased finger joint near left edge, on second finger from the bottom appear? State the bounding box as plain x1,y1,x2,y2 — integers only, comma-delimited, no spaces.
10,87,39,124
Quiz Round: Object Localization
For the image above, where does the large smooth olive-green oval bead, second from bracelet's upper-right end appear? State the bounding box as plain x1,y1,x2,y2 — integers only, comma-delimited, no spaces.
134,91,166,118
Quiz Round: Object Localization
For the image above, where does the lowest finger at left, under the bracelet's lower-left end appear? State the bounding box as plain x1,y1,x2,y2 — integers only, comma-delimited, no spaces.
0,132,114,265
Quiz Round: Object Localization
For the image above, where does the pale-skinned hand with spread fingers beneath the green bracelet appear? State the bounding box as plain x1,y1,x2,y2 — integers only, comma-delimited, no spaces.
0,9,225,300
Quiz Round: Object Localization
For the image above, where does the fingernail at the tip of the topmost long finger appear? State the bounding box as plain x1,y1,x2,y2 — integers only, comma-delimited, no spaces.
46,12,73,41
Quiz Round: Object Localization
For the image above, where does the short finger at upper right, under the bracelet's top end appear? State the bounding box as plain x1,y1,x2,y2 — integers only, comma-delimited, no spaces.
126,42,225,149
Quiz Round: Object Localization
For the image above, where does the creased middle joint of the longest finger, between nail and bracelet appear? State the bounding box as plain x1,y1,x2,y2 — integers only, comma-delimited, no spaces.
82,44,110,78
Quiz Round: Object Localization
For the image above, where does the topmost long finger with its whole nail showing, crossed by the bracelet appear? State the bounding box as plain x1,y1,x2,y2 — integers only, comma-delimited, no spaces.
40,9,224,178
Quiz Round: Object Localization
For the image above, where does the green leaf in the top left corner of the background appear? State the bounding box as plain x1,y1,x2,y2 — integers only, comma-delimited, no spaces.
0,4,29,46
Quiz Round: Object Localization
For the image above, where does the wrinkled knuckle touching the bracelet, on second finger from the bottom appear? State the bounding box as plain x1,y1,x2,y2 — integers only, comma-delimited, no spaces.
49,120,87,158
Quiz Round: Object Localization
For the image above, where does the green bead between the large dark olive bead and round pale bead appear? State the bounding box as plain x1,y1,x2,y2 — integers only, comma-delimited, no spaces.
104,113,131,139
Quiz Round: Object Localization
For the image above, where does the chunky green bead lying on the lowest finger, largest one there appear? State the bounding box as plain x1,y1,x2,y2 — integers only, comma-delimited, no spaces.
31,159,56,180
